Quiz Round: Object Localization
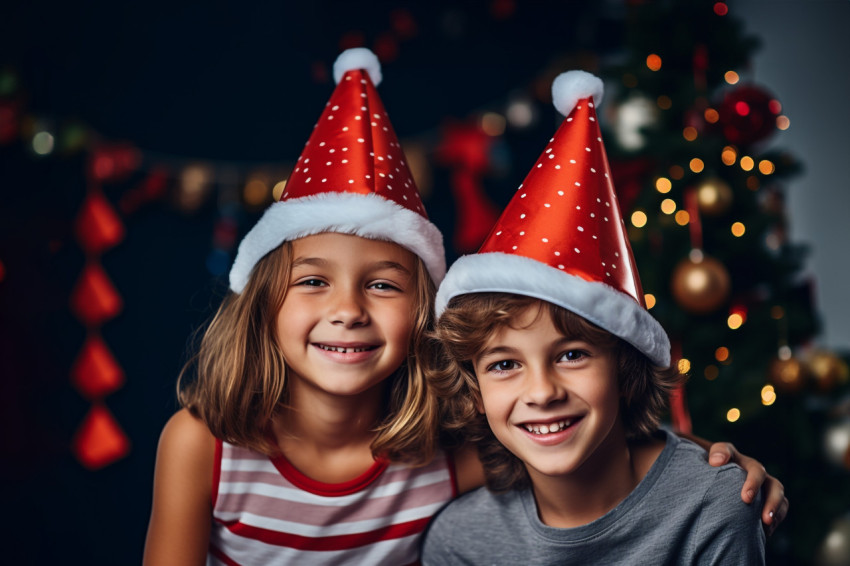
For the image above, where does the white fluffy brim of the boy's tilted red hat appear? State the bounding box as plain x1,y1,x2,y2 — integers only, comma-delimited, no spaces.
436,252,670,367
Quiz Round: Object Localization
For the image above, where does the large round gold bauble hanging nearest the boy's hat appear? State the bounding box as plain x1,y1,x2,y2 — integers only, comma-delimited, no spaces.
671,257,731,314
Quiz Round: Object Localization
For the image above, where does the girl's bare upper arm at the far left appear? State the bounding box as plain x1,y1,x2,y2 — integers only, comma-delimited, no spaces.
143,409,215,566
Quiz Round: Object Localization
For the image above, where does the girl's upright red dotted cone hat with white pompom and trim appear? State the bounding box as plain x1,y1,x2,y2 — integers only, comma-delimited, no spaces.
230,48,446,293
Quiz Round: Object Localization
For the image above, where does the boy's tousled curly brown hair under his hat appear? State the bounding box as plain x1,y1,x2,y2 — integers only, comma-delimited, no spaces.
428,293,684,491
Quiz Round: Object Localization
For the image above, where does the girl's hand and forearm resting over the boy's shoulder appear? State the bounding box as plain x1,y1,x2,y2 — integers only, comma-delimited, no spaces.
678,433,789,535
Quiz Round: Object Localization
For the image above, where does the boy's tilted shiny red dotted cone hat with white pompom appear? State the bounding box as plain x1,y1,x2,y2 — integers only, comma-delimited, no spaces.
436,71,670,367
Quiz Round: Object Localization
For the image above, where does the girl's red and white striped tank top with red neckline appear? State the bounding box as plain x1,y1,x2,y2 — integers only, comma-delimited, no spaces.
207,440,457,566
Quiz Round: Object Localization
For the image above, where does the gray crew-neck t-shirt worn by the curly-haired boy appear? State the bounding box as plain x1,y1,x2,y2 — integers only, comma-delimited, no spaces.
422,431,765,566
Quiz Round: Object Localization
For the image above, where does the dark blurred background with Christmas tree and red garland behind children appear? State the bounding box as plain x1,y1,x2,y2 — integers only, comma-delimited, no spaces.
0,0,850,565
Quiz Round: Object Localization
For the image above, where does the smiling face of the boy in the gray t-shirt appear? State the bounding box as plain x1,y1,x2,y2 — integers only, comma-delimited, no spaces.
474,304,624,480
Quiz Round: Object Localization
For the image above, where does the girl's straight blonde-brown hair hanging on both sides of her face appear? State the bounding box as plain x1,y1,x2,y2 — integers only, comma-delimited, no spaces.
177,241,438,465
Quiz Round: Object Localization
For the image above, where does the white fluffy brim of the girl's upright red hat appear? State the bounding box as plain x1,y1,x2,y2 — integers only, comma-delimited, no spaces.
230,192,446,293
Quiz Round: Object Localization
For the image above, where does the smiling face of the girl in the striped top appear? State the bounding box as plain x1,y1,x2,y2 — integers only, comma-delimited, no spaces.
277,233,416,402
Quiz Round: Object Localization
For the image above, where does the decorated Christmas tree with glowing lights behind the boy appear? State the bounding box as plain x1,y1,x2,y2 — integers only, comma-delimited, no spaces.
604,1,850,564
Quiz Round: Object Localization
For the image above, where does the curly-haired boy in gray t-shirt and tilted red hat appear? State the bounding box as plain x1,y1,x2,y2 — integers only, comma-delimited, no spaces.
423,71,764,565
